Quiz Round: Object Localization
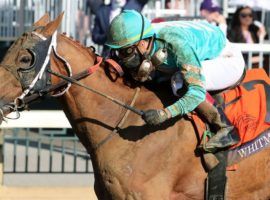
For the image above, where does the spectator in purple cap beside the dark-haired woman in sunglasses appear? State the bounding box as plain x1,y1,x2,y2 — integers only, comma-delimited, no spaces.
200,0,227,35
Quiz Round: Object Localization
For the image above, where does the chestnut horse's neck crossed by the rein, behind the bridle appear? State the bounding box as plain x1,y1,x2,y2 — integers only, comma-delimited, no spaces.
54,35,139,153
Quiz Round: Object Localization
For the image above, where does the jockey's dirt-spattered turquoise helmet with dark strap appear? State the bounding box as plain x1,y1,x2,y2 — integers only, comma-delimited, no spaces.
106,10,155,49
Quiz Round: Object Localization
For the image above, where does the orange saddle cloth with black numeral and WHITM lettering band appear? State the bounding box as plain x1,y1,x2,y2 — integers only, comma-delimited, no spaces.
192,69,270,166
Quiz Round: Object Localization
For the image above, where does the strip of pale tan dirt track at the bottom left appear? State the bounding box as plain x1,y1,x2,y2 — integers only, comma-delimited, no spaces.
0,187,97,200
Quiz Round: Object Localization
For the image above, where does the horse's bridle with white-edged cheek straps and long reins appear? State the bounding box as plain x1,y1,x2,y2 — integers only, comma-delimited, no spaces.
0,31,143,124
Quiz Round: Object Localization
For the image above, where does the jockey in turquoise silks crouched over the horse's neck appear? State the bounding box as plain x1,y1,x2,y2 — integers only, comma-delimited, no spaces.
106,10,244,149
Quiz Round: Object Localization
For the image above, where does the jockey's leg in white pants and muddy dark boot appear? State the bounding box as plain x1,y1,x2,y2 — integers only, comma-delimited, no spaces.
196,41,245,150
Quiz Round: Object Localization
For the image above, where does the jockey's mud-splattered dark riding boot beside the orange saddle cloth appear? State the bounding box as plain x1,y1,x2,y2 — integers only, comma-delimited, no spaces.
195,100,240,152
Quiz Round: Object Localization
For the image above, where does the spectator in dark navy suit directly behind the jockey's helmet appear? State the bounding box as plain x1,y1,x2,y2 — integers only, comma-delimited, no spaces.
92,0,147,57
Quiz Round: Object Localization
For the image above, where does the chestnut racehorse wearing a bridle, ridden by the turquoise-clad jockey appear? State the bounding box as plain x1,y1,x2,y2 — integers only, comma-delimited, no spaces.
0,15,270,200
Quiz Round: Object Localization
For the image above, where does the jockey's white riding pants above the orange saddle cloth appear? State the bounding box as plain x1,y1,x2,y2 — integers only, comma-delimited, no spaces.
171,40,245,95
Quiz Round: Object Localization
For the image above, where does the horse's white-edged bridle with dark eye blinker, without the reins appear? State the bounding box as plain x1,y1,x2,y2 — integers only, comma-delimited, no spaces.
0,30,72,119
